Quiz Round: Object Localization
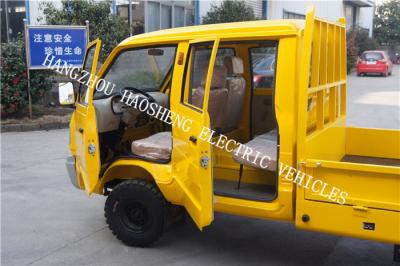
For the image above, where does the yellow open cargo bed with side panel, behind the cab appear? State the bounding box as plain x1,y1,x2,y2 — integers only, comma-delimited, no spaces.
297,125,400,243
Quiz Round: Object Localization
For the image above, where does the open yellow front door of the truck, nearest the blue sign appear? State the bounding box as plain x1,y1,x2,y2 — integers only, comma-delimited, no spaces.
74,39,101,195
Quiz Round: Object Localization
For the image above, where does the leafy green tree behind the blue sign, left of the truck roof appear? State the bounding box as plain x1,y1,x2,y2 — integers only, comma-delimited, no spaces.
41,0,129,62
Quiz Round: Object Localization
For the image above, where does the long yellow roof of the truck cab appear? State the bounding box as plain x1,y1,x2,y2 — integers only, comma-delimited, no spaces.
120,19,304,45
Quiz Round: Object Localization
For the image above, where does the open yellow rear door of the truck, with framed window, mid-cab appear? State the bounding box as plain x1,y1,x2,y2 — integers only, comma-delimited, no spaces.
171,39,219,229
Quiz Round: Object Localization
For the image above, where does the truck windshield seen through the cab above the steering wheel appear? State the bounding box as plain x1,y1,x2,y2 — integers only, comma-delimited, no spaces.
94,46,176,99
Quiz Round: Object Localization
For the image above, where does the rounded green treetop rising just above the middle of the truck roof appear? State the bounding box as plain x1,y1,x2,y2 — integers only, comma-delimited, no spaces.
203,0,257,24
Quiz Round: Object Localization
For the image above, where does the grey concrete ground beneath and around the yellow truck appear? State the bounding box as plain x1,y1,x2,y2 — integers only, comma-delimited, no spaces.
1,67,400,266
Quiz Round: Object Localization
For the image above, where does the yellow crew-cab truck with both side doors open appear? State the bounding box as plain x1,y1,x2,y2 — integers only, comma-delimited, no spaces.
60,8,400,259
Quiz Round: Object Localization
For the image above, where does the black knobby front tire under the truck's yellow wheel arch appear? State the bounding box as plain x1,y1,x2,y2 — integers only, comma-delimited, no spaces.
104,179,166,247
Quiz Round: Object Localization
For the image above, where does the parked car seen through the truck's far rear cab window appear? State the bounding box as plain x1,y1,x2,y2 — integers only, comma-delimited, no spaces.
253,56,275,88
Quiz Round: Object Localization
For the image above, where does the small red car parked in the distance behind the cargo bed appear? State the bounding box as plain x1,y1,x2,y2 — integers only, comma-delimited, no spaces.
357,50,392,77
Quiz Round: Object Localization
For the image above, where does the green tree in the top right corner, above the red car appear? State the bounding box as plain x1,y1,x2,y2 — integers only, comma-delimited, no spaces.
374,0,400,46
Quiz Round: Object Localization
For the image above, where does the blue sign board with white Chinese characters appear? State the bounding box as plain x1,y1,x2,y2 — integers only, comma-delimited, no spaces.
27,26,88,69
